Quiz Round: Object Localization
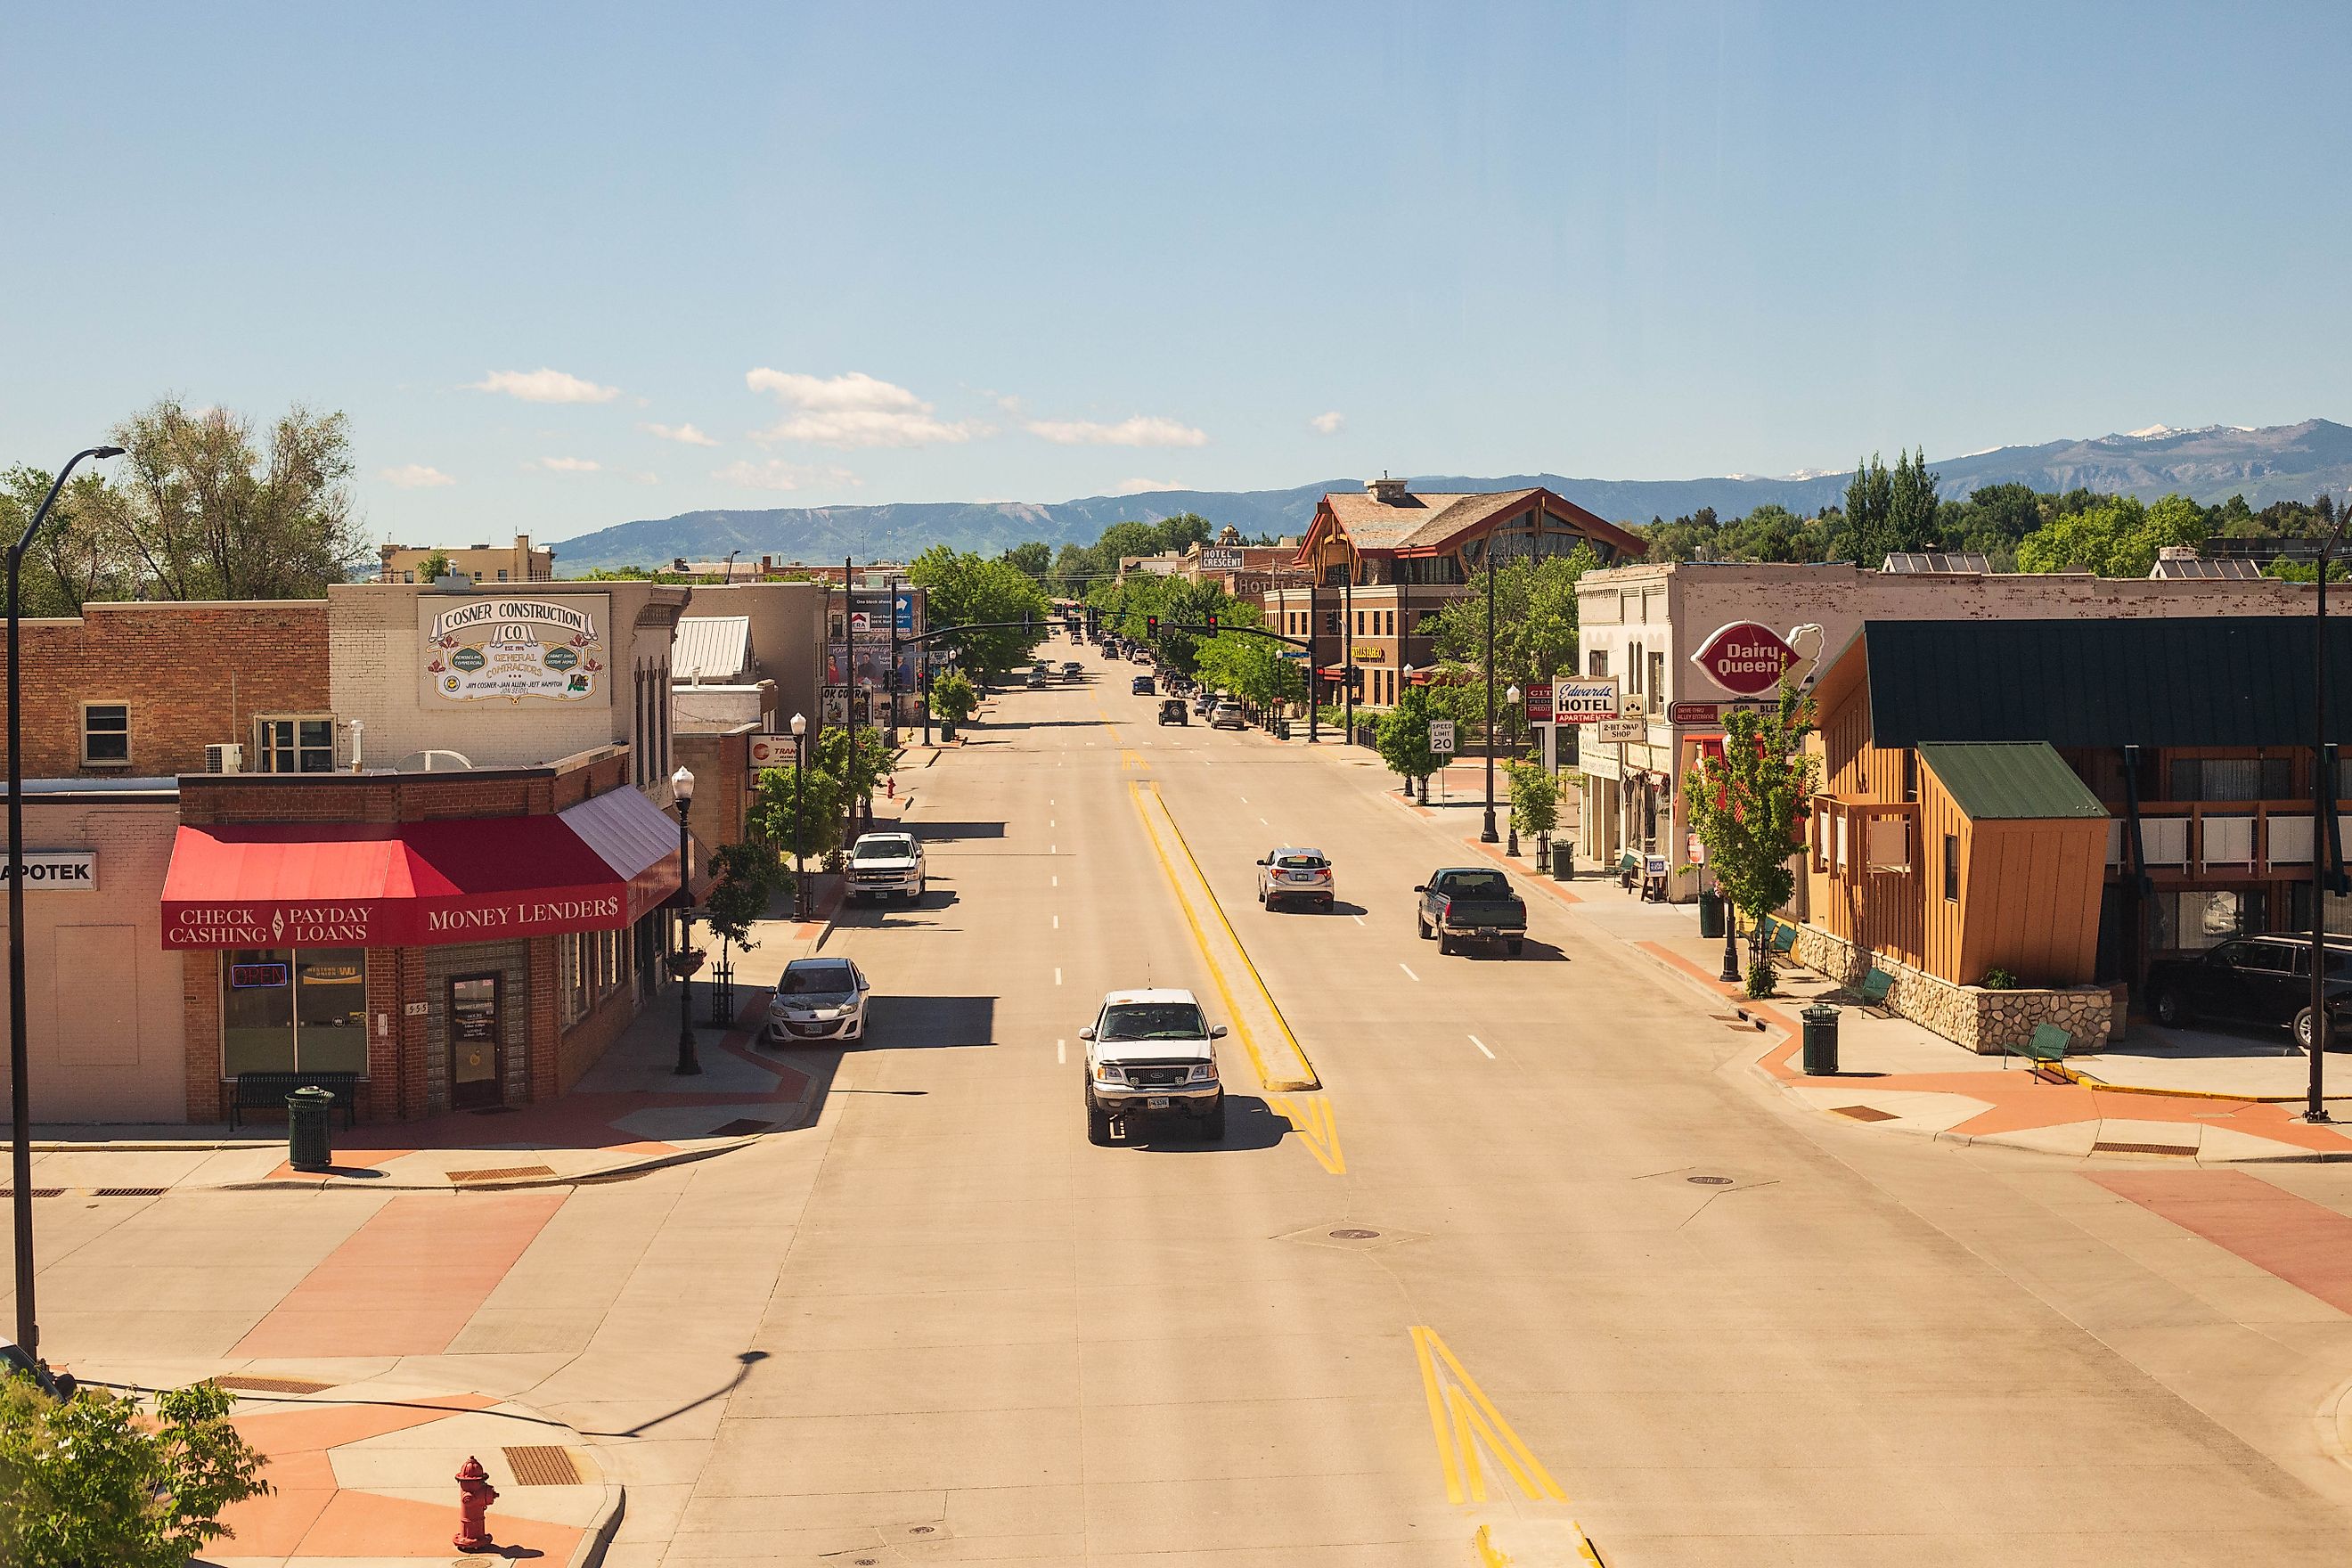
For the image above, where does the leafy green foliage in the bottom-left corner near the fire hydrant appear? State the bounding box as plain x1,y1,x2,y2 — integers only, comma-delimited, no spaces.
0,1376,271,1568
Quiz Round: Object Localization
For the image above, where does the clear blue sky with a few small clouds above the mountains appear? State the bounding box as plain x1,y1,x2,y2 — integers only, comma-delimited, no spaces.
13,0,2352,543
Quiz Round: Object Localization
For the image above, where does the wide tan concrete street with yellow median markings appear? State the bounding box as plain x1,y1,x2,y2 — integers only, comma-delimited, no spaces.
22,649,2352,1568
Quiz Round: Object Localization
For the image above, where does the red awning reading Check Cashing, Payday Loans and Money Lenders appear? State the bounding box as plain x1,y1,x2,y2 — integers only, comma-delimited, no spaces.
162,790,677,947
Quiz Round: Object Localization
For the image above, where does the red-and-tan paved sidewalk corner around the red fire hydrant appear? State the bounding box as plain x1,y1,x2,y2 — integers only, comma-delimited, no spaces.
202,1376,625,1568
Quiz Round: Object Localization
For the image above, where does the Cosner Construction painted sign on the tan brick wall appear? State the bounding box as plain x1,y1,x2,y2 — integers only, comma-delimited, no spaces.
416,595,611,707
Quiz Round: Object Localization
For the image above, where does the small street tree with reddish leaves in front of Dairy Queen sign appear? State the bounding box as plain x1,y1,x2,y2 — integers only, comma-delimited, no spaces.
1682,682,1816,997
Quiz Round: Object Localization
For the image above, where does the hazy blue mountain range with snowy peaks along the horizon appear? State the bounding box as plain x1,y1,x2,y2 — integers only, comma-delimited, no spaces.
555,419,2352,576
